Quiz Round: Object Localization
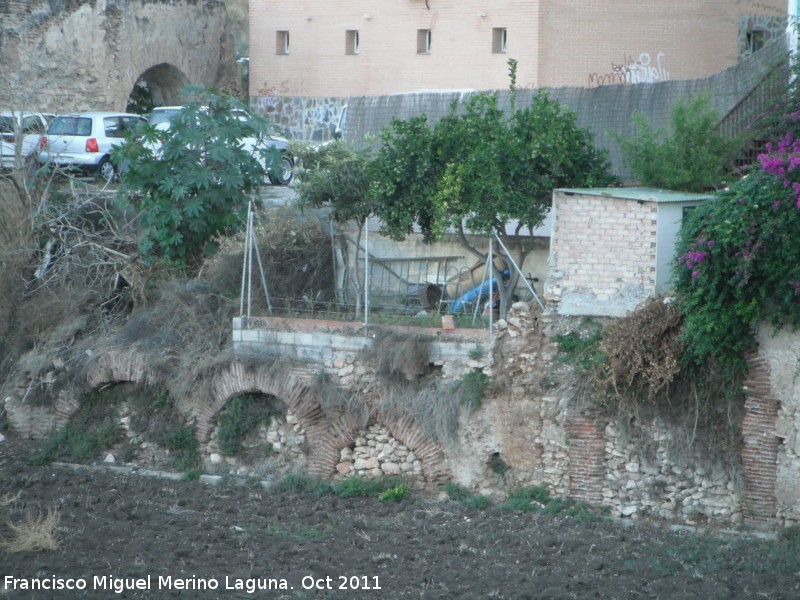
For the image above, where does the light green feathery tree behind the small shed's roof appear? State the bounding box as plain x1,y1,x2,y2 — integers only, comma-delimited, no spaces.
614,94,740,192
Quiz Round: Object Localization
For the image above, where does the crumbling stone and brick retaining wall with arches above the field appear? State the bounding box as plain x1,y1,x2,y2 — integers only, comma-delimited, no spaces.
5,310,800,527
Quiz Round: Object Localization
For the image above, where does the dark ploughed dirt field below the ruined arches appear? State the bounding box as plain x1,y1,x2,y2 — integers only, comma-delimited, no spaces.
0,436,800,600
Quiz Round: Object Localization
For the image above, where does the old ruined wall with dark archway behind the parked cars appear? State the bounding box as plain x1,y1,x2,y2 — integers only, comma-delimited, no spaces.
0,0,234,112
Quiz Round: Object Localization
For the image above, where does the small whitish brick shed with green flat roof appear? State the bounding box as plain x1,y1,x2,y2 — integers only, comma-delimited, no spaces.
544,188,713,317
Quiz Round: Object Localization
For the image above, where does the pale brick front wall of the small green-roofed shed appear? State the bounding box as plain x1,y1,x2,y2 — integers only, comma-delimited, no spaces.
545,191,658,317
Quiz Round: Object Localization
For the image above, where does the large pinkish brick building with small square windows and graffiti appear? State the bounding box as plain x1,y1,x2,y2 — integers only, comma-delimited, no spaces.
250,0,791,98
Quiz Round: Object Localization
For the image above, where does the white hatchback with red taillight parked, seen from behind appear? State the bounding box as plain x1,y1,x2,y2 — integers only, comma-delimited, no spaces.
38,112,146,181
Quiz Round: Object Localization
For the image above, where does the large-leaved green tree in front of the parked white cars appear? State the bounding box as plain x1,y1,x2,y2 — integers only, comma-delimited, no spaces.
114,90,279,265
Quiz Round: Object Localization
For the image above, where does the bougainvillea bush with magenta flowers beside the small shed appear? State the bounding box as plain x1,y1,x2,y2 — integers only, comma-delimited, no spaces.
676,134,800,367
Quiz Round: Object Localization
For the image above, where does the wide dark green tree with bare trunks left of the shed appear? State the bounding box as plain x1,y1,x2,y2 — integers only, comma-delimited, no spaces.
370,86,616,314
